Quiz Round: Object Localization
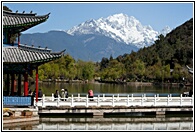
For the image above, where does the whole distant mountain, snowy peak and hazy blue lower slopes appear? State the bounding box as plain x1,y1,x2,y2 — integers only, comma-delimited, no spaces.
21,13,171,61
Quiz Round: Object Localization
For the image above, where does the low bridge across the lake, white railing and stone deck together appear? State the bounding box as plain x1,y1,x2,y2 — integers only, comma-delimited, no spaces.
35,95,193,115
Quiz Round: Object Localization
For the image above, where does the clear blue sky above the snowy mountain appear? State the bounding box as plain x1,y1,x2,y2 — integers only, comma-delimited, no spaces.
3,2,195,33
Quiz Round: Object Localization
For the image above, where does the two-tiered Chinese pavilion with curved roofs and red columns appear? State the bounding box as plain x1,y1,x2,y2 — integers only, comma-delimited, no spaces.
3,10,65,105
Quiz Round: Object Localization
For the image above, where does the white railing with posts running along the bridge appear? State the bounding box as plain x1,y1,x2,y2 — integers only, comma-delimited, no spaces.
34,94,194,107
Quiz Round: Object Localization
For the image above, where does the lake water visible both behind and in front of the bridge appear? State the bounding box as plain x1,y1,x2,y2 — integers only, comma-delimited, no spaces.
4,83,194,131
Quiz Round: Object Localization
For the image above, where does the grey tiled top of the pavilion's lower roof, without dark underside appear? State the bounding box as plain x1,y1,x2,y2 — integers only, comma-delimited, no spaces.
3,44,65,64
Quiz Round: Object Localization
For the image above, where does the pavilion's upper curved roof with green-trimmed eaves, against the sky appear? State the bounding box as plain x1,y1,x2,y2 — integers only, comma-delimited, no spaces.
3,11,50,33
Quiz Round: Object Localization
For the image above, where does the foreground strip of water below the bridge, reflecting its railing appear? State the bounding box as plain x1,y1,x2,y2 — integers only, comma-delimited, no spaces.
4,117,193,131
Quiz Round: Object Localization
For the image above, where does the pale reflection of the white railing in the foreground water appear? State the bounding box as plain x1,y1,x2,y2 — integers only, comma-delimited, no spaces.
37,122,193,130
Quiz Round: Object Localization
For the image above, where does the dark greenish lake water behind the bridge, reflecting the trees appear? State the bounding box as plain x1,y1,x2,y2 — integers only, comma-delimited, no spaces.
30,82,191,96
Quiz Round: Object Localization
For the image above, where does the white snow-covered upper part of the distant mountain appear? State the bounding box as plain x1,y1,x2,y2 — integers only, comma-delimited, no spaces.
66,13,165,48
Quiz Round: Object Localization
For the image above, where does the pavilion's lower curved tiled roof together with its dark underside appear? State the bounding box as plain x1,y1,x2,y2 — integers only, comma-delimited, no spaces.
3,44,65,73
